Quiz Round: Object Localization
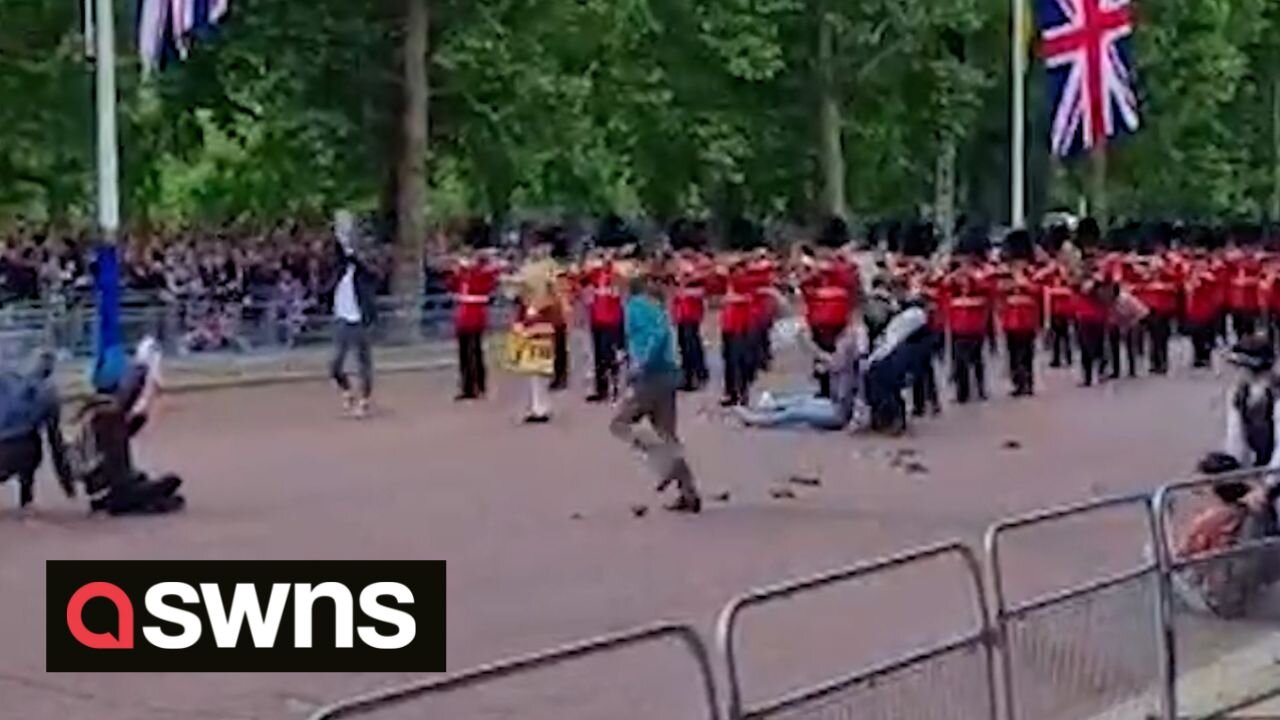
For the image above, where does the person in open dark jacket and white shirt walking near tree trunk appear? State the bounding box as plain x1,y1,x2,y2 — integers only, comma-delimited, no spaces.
328,210,378,418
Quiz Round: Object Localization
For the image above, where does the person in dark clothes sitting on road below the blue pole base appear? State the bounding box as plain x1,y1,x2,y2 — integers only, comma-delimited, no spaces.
67,343,186,515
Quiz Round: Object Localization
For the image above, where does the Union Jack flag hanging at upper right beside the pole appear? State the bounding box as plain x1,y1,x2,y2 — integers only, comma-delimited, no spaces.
1036,0,1140,156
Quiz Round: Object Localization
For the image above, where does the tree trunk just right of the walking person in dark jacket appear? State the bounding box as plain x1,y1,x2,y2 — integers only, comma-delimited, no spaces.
392,0,430,340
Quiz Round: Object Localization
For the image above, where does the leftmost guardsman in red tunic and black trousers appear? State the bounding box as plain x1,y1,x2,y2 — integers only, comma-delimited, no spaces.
448,252,498,401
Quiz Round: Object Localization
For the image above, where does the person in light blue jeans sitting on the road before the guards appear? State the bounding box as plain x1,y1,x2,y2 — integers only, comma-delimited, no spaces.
736,322,868,430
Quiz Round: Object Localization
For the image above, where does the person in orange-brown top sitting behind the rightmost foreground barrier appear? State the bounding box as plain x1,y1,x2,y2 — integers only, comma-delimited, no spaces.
1172,452,1276,619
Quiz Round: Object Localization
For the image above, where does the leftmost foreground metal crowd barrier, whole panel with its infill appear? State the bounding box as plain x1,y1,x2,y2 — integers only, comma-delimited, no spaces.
303,623,719,720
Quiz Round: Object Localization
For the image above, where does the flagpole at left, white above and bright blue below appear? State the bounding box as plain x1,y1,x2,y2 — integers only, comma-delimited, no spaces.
87,0,123,377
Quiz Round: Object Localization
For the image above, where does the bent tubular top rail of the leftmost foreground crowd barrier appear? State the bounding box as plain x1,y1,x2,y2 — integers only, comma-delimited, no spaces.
311,623,719,720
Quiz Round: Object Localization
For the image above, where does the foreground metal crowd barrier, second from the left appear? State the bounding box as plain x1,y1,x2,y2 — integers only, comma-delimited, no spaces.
717,542,996,720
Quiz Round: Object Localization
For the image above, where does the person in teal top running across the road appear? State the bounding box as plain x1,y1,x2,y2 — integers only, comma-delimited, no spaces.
609,267,703,514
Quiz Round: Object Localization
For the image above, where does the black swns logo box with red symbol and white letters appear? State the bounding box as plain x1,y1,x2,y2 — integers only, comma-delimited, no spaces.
45,560,445,673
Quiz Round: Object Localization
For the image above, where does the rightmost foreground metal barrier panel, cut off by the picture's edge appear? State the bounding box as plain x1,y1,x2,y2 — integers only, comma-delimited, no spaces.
1152,470,1280,719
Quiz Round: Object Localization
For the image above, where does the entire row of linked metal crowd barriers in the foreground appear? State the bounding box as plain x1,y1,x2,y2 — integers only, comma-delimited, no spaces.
311,471,1280,720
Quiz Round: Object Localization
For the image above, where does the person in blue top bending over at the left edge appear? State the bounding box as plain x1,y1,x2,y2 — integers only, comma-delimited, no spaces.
0,351,72,507
